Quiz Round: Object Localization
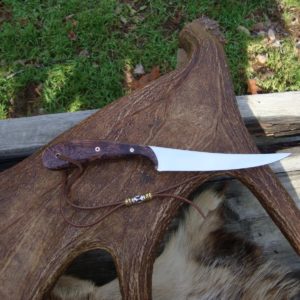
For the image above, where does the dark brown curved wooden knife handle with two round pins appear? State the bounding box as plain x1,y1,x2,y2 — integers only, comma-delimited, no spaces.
43,140,158,170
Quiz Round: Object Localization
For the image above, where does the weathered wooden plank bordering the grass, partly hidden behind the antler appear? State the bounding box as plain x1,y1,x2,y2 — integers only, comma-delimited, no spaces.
0,92,300,159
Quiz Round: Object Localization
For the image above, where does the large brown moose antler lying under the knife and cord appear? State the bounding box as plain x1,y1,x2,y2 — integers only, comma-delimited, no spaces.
0,20,300,300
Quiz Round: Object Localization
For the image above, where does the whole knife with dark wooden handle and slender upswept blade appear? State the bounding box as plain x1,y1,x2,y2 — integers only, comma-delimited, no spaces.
43,140,290,172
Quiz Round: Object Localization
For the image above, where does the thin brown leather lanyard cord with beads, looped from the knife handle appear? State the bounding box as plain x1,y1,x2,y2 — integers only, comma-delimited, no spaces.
59,154,205,228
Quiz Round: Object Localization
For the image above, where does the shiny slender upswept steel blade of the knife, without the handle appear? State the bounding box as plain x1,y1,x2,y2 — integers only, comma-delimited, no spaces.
150,146,290,172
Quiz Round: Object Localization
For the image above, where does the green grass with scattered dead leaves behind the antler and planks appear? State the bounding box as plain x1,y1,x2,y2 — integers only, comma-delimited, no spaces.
0,0,300,118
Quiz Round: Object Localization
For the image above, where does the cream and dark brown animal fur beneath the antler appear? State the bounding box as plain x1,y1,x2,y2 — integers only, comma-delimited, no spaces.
51,190,300,300
